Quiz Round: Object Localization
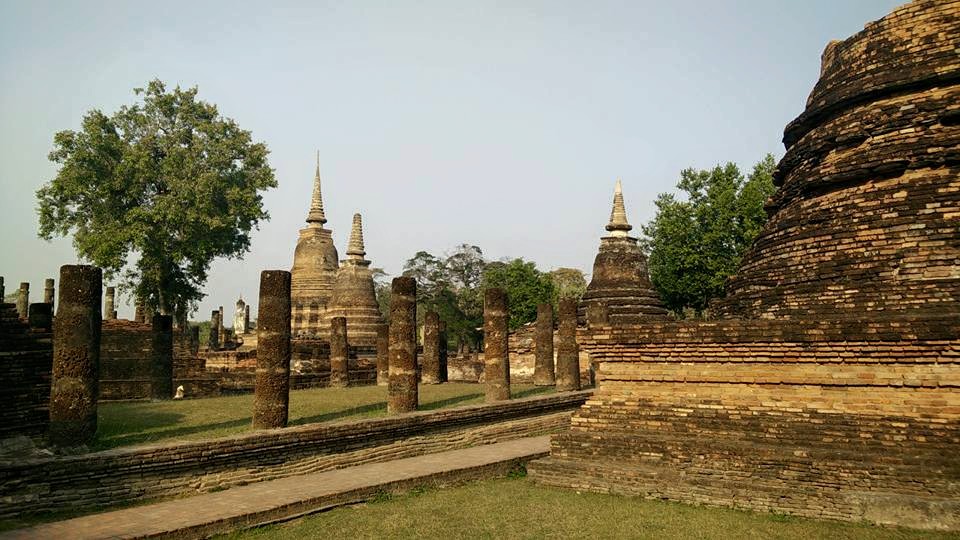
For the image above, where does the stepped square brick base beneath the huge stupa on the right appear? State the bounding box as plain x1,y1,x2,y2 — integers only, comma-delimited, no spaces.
531,317,960,529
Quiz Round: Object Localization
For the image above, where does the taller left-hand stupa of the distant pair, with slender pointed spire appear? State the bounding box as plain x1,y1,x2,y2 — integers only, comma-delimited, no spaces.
290,153,339,335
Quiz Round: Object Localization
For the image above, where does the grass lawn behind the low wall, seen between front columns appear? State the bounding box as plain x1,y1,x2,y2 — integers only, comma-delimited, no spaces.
93,383,553,450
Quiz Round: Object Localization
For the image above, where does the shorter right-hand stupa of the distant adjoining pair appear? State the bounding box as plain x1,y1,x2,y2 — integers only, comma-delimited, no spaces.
320,214,384,346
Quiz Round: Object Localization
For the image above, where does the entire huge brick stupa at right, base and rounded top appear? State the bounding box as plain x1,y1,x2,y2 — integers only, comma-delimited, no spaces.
528,0,960,531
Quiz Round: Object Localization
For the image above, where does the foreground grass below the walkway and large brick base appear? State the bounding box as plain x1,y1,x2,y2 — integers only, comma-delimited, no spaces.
226,478,957,540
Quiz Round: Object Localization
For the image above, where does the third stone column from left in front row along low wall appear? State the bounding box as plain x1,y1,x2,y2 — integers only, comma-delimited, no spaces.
387,277,418,413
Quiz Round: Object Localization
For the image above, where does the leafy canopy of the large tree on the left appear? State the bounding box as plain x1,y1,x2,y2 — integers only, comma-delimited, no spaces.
37,80,277,316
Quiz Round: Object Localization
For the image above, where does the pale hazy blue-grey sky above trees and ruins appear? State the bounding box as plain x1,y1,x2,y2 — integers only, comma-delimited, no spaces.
0,0,902,319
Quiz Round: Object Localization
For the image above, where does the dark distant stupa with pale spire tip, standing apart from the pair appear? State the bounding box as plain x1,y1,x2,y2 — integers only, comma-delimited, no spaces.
578,180,667,325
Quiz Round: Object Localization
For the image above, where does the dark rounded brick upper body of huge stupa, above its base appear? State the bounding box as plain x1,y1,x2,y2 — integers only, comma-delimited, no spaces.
716,1,960,320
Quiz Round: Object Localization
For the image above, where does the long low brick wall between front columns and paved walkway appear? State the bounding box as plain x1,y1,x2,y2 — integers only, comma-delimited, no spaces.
0,392,589,517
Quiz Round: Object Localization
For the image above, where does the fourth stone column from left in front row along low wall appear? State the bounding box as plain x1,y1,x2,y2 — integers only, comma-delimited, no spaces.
483,288,510,401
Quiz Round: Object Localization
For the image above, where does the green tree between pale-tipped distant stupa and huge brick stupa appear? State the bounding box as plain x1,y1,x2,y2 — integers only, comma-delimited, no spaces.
643,154,776,316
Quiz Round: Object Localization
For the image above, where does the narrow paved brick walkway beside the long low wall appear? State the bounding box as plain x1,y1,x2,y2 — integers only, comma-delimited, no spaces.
0,435,550,540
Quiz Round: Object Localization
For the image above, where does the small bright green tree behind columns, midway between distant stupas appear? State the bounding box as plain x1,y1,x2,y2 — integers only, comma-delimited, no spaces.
483,259,554,330
